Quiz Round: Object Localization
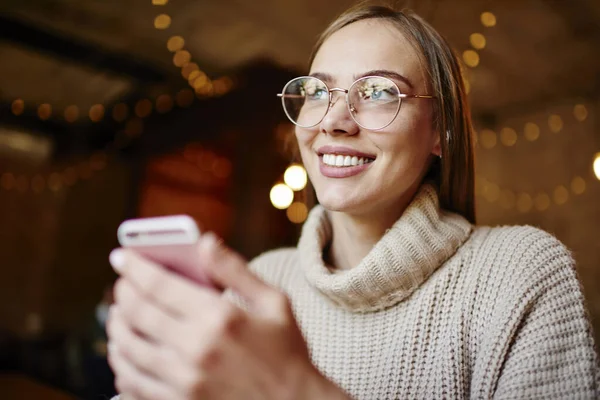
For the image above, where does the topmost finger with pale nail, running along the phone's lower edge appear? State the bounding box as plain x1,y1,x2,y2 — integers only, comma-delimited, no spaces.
111,249,220,317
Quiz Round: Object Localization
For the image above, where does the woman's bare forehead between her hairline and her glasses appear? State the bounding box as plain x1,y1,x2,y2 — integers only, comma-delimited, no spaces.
311,19,426,88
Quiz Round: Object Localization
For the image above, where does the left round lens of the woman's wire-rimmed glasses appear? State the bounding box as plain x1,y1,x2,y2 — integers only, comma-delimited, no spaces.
282,77,329,127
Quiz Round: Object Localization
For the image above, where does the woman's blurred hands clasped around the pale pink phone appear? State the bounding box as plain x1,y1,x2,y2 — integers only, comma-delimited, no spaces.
108,234,345,400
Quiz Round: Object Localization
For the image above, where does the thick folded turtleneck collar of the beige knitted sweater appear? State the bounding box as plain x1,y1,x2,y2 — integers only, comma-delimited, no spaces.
298,184,472,312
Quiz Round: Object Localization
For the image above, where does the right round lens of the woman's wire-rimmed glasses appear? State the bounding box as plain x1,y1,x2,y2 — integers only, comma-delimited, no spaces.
348,77,400,130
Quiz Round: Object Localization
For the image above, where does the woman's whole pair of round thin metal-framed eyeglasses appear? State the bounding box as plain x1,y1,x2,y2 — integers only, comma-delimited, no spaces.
277,76,435,130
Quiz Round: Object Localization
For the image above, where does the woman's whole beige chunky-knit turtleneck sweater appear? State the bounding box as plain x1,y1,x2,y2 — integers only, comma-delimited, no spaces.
251,185,600,400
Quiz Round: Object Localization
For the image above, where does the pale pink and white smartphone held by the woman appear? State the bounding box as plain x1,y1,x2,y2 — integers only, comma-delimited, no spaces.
117,215,212,286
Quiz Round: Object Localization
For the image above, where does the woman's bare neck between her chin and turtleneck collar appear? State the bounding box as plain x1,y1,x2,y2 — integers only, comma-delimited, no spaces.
324,189,416,270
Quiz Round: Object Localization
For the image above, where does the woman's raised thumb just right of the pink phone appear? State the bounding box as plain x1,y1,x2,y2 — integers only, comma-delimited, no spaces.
199,232,275,305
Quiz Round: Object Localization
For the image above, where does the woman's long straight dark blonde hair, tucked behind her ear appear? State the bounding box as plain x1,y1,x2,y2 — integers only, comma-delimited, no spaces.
310,4,475,223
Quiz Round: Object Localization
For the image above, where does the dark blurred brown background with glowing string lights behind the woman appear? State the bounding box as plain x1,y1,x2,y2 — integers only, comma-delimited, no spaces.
0,0,600,399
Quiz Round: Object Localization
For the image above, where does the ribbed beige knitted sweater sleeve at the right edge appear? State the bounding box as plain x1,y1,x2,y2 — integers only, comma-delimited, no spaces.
486,240,600,399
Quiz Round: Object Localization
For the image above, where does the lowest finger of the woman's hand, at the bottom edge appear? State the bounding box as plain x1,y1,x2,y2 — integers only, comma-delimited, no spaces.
108,344,178,400
